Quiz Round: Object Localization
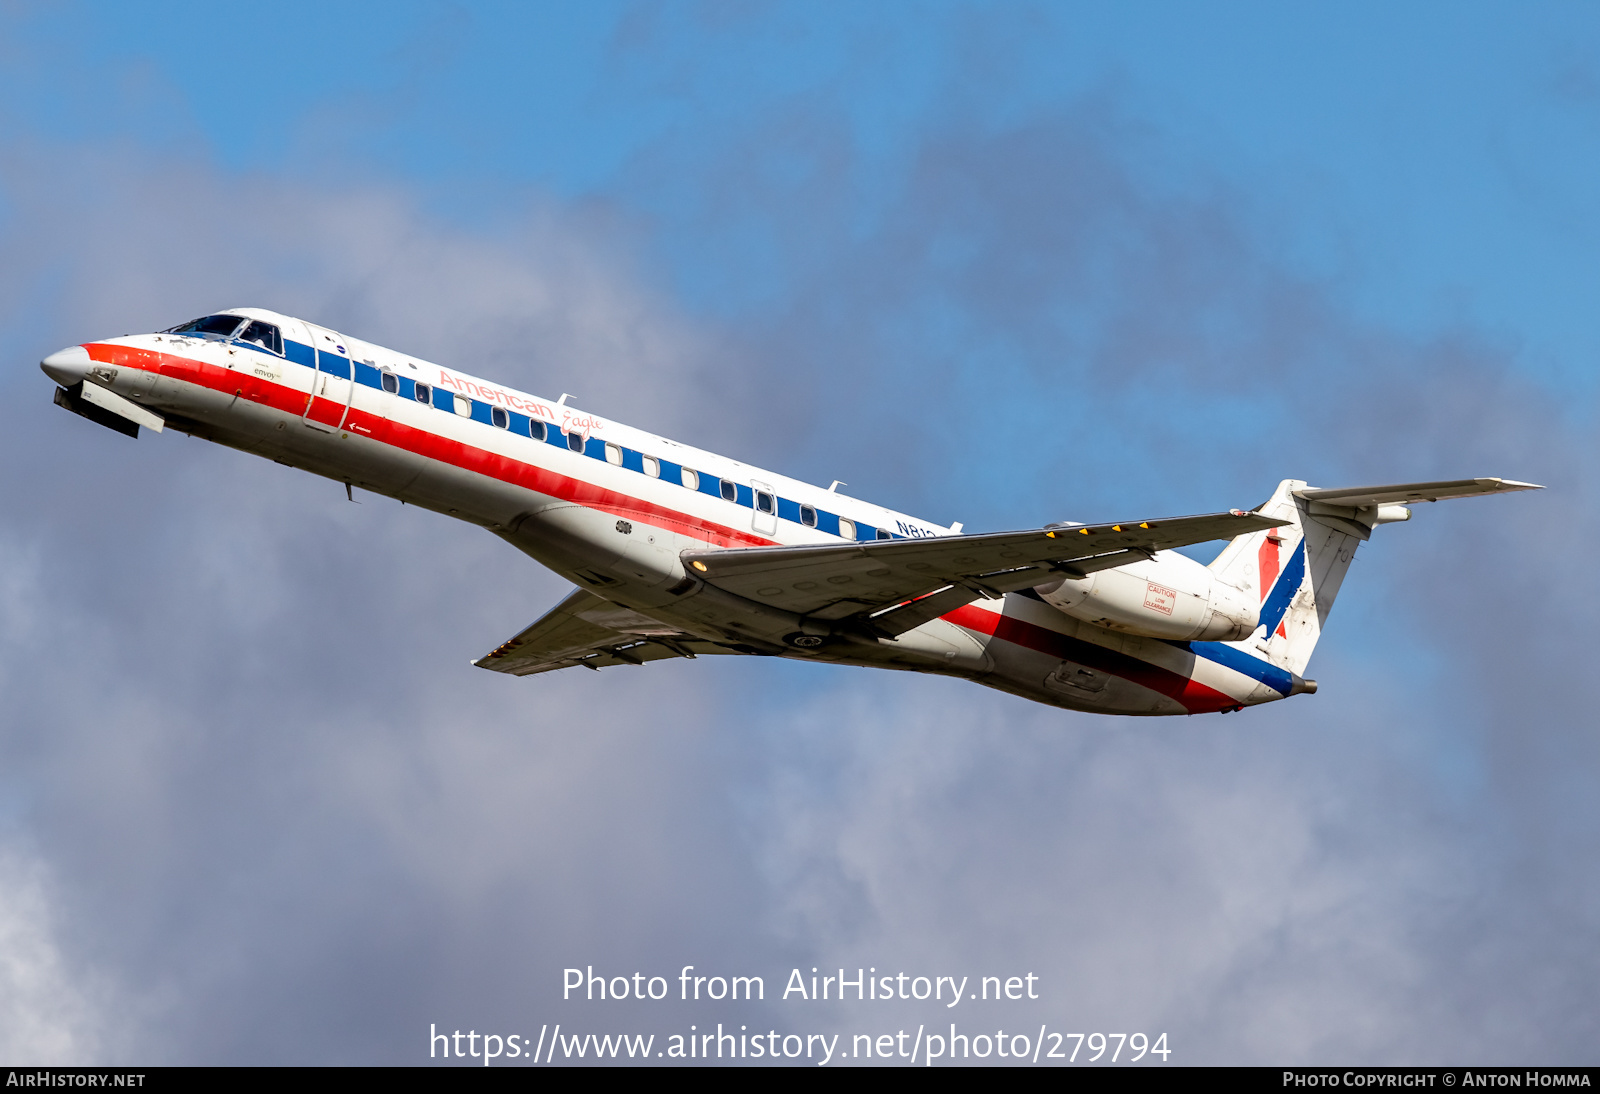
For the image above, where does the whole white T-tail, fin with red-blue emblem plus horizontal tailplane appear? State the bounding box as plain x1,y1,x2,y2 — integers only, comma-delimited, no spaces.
1211,478,1541,675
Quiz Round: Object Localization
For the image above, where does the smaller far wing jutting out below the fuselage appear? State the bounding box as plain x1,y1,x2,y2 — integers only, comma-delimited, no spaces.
472,589,739,677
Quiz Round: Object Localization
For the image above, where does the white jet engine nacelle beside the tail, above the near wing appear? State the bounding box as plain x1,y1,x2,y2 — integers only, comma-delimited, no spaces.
1034,552,1261,641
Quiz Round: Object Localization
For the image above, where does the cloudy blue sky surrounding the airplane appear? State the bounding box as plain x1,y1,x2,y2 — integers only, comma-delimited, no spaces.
0,2,1600,1064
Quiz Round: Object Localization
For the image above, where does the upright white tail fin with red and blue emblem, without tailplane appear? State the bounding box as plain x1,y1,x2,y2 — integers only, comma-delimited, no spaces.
1211,478,1371,675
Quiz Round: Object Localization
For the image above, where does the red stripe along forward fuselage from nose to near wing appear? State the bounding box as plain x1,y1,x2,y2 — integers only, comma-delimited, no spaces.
85,342,778,547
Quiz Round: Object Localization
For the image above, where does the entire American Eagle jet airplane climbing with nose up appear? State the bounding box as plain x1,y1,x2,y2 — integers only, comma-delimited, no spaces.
40,307,1541,715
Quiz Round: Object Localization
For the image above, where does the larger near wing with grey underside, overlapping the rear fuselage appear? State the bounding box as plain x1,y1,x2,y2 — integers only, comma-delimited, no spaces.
683,510,1288,635
